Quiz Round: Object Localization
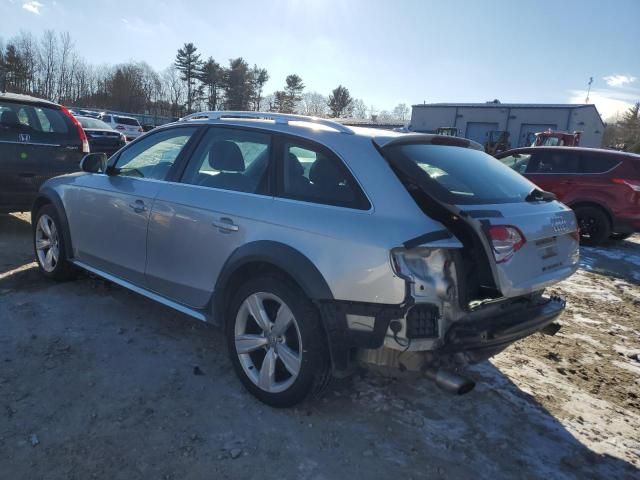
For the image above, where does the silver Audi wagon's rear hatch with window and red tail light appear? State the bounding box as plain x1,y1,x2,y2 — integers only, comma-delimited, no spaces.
381,135,578,297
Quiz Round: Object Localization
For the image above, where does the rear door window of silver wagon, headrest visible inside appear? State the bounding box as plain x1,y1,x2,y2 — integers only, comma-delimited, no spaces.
182,128,271,193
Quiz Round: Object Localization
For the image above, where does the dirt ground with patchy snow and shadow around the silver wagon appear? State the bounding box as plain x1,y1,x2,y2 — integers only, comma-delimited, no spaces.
0,215,640,480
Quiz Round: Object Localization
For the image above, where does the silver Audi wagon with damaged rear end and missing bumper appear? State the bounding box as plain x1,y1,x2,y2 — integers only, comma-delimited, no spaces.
32,112,578,407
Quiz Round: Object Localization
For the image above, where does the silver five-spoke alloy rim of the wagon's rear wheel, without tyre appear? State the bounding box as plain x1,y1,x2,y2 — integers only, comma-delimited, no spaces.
234,292,302,393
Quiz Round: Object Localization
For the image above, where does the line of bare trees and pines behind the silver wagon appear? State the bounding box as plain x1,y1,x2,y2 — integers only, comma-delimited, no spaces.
0,30,409,123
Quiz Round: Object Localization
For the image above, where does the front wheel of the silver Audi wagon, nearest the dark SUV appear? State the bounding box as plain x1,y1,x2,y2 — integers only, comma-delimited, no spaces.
33,205,75,280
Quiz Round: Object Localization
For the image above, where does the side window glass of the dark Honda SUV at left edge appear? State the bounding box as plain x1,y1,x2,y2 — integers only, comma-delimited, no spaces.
0,102,69,134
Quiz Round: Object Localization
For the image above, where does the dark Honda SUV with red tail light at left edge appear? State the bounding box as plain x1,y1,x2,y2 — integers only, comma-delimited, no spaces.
0,93,89,213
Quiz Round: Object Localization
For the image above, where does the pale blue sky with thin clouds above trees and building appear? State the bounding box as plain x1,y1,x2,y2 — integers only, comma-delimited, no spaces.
0,0,640,118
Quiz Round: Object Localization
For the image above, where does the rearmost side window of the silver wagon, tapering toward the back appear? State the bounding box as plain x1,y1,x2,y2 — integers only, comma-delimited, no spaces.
279,138,370,210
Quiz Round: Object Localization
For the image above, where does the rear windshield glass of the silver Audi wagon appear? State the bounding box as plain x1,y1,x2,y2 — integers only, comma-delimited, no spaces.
385,144,535,205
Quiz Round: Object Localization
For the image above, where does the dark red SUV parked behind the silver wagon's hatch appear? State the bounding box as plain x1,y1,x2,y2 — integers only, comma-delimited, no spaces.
497,147,640,245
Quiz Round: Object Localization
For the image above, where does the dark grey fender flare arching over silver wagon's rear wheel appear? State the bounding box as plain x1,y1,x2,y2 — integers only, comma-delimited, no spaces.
213,240,334,326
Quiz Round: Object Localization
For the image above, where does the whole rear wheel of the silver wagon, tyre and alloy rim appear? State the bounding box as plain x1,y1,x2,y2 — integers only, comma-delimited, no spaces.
226,276,330,407
